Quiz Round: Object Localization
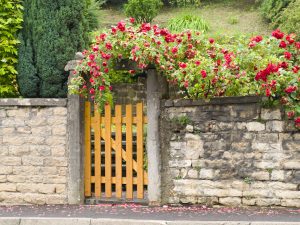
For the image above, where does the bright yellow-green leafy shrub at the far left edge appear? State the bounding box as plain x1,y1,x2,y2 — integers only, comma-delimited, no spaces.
0,0,22,98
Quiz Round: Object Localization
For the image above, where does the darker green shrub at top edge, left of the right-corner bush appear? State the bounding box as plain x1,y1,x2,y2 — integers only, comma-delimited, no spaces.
260,0,293,22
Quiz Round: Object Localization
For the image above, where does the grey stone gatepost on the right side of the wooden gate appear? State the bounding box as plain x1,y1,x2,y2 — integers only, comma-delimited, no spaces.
147,69,167,205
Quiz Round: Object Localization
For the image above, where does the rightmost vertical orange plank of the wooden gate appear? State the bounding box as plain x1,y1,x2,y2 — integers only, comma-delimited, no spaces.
136,103,144,199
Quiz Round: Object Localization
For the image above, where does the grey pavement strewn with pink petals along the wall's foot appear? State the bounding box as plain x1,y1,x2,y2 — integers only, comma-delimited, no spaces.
0,204,300,225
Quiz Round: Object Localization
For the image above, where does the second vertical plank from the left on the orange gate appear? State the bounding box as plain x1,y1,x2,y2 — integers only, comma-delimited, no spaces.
94,105,101,197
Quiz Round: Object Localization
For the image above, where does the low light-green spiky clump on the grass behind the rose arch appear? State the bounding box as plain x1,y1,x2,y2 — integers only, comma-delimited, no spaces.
167,14,209,33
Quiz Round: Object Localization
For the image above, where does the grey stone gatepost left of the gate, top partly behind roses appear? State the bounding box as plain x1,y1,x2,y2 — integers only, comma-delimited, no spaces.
65,53,84,204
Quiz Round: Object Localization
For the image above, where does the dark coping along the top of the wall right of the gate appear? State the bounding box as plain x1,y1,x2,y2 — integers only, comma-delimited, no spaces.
161,96,263,108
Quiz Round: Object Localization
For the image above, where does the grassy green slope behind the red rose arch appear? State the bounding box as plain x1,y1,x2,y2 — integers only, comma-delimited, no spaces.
99,0,271,35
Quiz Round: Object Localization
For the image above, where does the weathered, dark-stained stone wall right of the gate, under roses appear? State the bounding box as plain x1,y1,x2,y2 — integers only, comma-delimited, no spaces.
160,97,300,207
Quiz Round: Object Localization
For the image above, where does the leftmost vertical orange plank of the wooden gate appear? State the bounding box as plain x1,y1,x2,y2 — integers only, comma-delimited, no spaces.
84,101,91,197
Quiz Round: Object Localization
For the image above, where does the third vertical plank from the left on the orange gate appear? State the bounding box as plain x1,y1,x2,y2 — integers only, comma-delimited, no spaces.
105,104,111,198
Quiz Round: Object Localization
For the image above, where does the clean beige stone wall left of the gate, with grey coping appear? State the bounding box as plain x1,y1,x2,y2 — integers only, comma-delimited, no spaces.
0,99,69,205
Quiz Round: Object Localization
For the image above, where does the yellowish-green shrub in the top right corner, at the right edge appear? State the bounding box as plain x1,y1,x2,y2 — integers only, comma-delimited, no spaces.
277,0,300,36
